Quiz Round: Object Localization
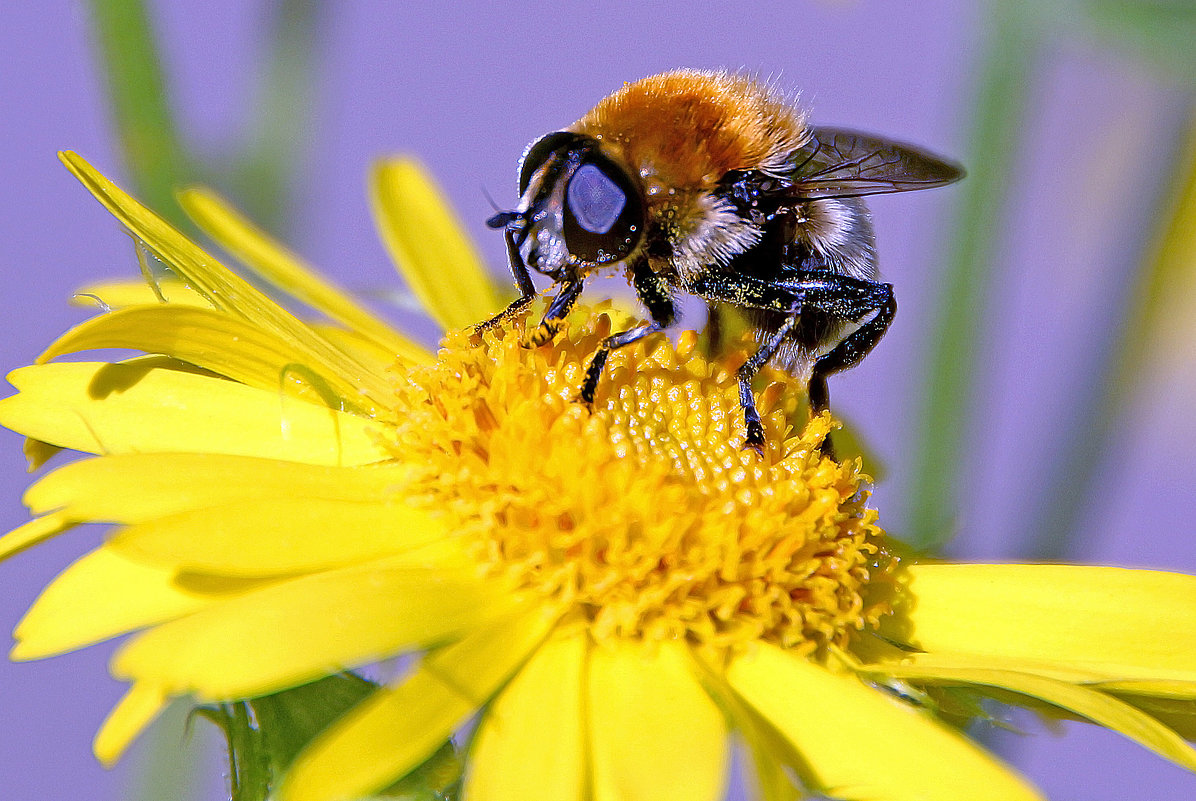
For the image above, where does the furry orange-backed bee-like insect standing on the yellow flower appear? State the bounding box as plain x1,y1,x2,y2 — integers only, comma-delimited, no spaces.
482,69,963,455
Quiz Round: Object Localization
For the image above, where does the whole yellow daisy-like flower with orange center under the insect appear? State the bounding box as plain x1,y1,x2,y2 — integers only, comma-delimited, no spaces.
7,154,1196,801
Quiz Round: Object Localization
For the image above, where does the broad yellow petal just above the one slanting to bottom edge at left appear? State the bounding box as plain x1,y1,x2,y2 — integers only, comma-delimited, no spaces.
112,563,509,699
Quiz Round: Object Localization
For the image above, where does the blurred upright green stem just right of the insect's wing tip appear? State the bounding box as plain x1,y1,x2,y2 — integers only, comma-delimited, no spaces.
907,0,1042,551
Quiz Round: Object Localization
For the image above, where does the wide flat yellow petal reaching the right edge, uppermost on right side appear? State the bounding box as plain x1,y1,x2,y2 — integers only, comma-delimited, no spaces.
889,564,1196,683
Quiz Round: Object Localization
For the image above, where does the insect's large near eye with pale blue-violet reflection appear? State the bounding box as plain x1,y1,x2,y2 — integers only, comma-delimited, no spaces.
565,158,643,263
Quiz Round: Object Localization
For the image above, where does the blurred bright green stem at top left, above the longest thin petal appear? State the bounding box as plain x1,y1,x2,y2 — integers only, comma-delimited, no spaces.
90,0,193,226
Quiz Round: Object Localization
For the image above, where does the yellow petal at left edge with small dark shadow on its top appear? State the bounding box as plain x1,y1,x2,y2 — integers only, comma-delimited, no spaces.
0,357,390,465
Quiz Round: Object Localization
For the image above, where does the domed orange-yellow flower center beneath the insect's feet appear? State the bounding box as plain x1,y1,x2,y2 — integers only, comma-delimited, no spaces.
389,311,889,650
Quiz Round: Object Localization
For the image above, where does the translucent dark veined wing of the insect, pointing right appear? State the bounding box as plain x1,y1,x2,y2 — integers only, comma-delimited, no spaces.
787,128,964,200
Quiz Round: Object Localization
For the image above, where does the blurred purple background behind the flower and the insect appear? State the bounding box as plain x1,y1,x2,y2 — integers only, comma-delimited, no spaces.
0,0,1196,801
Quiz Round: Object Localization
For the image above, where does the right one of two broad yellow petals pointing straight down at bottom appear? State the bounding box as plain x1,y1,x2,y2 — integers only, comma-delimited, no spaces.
590,642,728,801
